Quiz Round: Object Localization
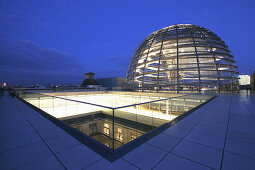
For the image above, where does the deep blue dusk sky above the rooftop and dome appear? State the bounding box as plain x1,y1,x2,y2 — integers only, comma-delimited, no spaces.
0,0,255,84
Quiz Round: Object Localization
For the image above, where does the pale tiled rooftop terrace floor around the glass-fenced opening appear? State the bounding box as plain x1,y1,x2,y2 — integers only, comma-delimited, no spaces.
0,93,255,170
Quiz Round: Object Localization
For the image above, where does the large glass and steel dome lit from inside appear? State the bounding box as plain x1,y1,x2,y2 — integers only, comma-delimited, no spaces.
127,24,238,92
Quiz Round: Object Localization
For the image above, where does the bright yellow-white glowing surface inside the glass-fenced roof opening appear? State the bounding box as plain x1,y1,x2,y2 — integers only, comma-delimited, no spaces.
26,92,183,120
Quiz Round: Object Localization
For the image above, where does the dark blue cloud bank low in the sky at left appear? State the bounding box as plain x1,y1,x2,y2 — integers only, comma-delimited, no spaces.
0,32,84,84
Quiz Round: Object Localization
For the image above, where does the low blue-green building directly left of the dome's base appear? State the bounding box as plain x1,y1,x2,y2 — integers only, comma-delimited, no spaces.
96,77,127,90
